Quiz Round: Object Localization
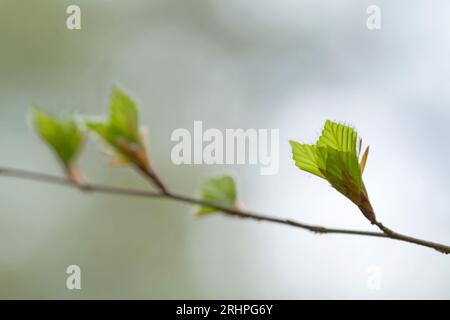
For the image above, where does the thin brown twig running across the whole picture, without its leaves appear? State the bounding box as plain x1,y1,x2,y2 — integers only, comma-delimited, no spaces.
0,167,450,254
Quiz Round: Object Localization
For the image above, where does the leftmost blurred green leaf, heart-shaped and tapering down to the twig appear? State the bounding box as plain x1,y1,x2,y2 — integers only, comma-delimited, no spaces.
32,107,85,168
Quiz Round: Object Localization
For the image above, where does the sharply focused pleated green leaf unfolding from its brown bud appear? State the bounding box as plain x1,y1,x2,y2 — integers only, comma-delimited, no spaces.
290,120,376,223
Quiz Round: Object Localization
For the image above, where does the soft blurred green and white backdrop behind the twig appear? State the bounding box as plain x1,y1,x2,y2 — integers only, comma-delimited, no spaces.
0,0,450,299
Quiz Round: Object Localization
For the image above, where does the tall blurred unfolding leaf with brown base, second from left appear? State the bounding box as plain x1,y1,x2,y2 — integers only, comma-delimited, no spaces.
86,89,149,170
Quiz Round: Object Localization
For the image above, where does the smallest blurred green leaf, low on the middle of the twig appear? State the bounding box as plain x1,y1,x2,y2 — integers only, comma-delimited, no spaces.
197,176,237,215
